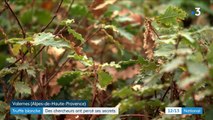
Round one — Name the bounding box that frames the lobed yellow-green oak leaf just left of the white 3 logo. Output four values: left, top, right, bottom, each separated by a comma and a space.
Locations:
156, 6, 187, 27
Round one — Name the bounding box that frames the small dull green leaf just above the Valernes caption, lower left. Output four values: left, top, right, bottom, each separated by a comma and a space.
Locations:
14, 82, 31, 94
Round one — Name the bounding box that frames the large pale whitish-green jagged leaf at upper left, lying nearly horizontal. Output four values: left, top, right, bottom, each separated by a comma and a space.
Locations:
32, 33, 70, 48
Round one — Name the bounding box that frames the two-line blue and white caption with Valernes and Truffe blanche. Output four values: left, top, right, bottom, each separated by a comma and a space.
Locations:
10, 100, 119, 115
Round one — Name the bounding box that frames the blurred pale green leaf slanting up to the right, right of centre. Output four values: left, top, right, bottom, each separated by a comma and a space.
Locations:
161, 57, 184, 72
